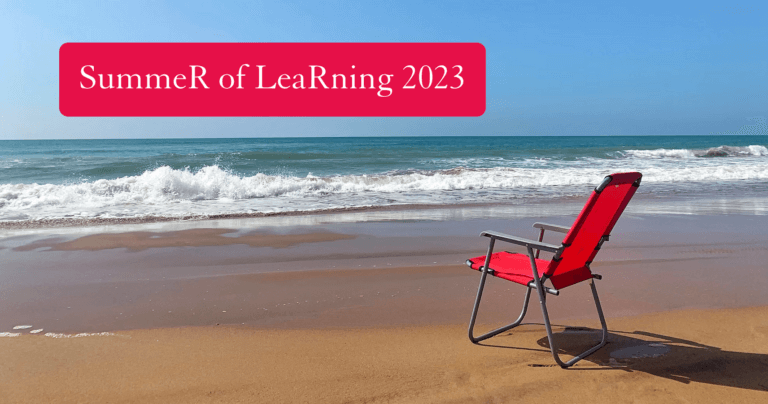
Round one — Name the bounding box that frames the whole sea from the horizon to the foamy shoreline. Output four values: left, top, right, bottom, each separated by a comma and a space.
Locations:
0, 135, 768, 223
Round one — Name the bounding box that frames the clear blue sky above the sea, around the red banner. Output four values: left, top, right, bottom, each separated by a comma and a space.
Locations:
0, 0, 768, 139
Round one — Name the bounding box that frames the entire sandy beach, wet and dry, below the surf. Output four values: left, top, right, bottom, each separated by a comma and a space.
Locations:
0, 213, 768, 403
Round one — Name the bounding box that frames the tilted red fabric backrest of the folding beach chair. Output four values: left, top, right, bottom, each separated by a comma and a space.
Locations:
545, 172, 642, 289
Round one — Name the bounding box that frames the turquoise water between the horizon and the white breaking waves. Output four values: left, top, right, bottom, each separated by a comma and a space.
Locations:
0, 136, 768, 184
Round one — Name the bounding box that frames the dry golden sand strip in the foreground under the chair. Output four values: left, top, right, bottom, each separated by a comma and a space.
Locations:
0, 307, 768, 403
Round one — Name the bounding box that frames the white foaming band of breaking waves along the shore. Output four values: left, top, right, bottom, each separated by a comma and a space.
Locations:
0, 145, 768, 221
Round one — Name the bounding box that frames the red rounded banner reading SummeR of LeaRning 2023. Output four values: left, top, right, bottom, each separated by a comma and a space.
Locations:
59, 43, 486, 117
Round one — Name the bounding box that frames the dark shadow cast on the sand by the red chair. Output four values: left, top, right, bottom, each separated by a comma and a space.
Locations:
480, 323, 768, 392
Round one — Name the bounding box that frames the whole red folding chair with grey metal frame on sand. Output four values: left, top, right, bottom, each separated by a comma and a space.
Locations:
467, 172, 642, 368
